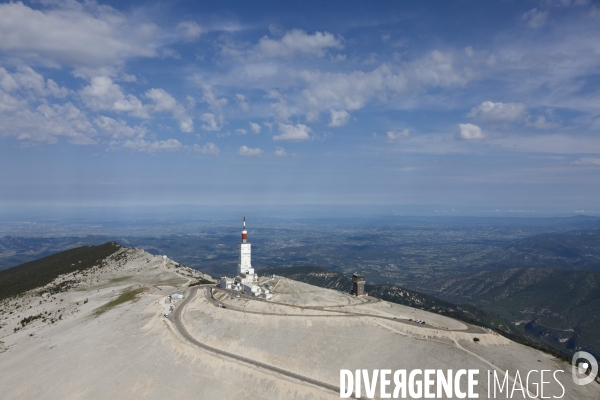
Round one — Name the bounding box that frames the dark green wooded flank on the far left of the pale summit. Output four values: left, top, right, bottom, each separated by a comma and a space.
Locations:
0, 242, 122, 300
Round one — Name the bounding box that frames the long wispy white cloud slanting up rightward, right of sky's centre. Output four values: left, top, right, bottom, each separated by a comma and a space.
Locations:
258, 50, 478, 122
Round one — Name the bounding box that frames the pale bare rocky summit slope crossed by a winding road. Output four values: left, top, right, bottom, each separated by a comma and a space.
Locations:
0, 248, 600, 399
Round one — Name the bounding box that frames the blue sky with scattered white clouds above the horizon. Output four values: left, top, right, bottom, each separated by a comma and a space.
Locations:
0, 0, 600, 213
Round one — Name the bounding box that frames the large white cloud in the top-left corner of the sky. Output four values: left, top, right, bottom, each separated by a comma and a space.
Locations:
0, 1, 158, 69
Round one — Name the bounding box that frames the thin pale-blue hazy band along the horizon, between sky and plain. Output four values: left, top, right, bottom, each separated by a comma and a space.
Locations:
0, 203, 600, 221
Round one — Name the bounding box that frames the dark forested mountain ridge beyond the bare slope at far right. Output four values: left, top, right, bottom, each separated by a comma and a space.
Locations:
427, 268, 600, 360
